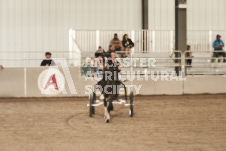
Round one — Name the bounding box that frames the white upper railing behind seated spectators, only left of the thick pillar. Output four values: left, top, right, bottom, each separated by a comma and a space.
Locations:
72, 30, 175, 52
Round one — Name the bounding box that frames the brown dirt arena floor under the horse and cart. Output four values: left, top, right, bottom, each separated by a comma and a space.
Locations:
0, 95, 226, 151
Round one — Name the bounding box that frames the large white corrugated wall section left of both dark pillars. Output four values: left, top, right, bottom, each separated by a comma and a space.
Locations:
0, 0, 142, 55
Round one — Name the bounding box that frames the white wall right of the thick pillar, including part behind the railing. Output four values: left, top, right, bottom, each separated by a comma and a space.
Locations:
187, 0, 226, 51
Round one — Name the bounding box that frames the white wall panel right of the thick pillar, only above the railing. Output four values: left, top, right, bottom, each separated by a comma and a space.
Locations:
187, 0, 226, 30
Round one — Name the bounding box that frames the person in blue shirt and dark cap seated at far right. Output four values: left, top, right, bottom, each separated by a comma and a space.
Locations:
212, 35, 226, 62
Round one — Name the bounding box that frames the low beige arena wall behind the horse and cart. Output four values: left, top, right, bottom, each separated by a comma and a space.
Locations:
0, 67, 226, 97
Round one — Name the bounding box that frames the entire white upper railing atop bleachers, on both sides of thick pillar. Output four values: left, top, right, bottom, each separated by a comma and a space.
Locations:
73, 30, 226, 52
